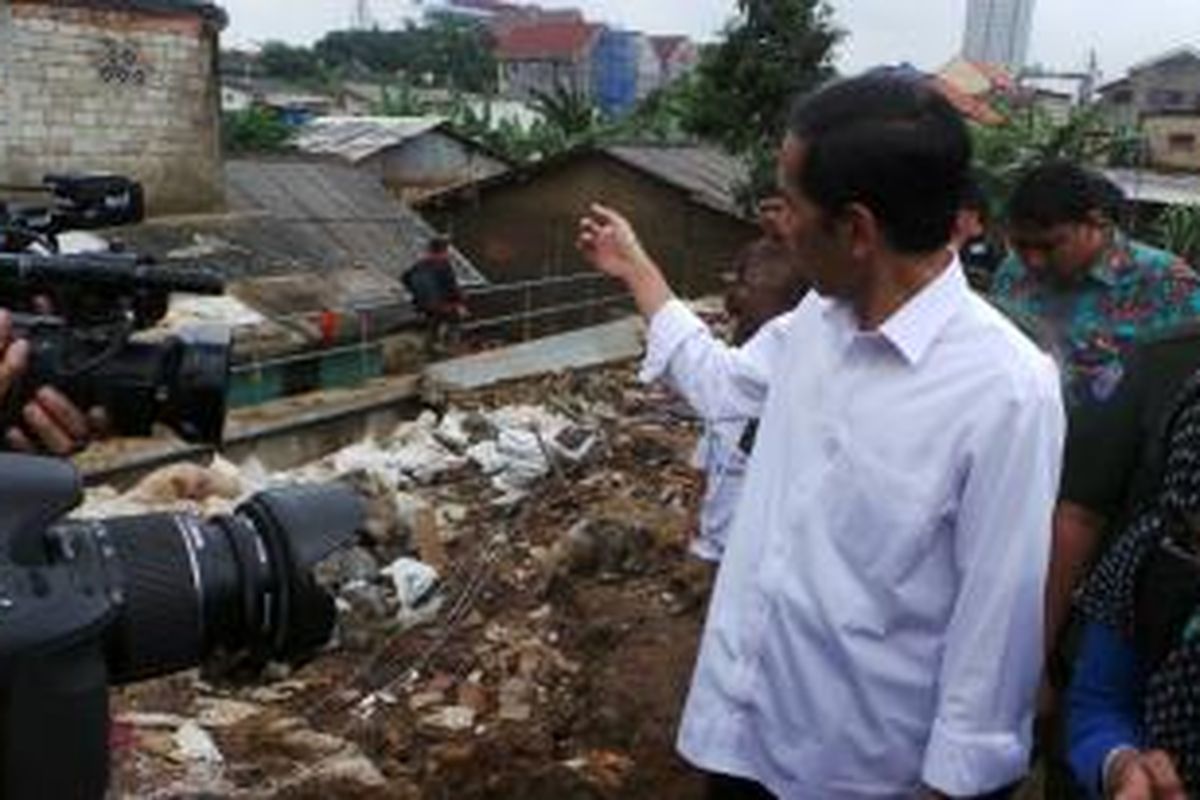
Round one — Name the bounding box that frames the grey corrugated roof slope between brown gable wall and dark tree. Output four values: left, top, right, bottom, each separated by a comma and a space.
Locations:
604, 145, 750, 216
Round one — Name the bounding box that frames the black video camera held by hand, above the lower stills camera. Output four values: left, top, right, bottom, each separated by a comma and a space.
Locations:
0, 175, 232, 444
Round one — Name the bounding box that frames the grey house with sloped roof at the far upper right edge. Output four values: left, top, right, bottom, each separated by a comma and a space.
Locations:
1097, 47, 1200, 127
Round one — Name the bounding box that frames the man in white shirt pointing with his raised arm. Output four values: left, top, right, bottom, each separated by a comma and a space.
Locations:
580, 72, 1063, 800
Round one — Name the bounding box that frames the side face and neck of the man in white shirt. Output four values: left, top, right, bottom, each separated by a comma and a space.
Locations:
779, 136, 865, 299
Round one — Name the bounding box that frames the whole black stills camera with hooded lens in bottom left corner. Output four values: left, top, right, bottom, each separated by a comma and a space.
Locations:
0, 455, 364, 800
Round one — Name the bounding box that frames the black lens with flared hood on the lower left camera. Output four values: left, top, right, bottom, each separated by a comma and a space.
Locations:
53, 485, 364, 684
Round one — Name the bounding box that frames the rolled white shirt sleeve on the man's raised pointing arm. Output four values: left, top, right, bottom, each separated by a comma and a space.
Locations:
641, 300, 798, 425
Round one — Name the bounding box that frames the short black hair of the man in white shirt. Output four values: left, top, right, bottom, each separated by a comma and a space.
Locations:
788, 68, 971, 253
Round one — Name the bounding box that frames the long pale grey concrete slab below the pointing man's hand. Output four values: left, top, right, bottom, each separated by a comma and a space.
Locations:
424, 317, 646, 397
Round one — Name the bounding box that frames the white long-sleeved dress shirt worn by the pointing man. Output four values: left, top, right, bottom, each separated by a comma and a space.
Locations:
642, 263, 1064, 800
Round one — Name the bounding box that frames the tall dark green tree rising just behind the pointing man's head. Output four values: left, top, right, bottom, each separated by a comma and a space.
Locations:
684, 0, 842, 169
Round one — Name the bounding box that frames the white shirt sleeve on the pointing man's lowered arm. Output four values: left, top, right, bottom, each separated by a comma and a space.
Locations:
922, 360, 1066, 796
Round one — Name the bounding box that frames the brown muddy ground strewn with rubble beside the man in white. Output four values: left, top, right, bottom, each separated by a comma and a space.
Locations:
112, 366, 710, 800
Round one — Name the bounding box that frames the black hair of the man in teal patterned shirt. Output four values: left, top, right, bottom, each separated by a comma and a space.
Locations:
1008, 161, 1126, 228
